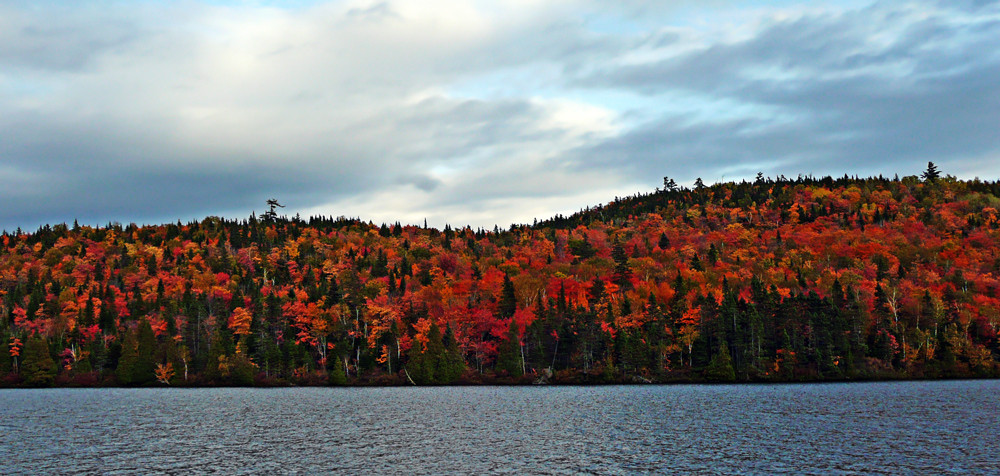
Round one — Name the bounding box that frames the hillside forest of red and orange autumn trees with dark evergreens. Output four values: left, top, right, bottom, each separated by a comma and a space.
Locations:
0, 164, 1000, 387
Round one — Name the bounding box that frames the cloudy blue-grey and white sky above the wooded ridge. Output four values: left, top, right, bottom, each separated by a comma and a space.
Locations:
0, 0, 1000, 230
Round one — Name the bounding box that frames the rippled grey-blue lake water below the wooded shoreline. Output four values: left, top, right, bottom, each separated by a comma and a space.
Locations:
0, 380, 1000, 474
